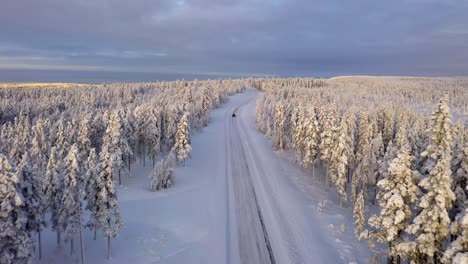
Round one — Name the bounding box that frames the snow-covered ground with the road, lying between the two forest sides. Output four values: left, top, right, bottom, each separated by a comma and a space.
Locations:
39, 89, 370, 264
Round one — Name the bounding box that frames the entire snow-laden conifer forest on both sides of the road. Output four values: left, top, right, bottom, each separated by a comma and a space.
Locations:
0, 77, 468, 263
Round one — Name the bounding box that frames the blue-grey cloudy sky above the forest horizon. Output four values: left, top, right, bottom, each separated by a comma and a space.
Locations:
0, 0, 468, 80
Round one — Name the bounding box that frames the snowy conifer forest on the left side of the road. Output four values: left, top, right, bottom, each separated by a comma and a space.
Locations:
0, 80, 248, 263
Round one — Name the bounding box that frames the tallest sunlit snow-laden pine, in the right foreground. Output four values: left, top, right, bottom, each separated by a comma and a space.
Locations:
398, 96, 455, 262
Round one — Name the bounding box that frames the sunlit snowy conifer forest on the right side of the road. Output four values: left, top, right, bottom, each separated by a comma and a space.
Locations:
253, 77, 468, 264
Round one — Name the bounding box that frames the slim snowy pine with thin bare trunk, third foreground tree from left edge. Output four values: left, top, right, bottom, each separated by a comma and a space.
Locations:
44, 147, 63, 246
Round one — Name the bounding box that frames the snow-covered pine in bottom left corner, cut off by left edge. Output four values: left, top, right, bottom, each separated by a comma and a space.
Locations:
0, 154, 34, 264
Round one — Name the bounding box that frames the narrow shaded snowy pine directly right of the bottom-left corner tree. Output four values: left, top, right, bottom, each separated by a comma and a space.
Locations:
16, 153, 46, 258
